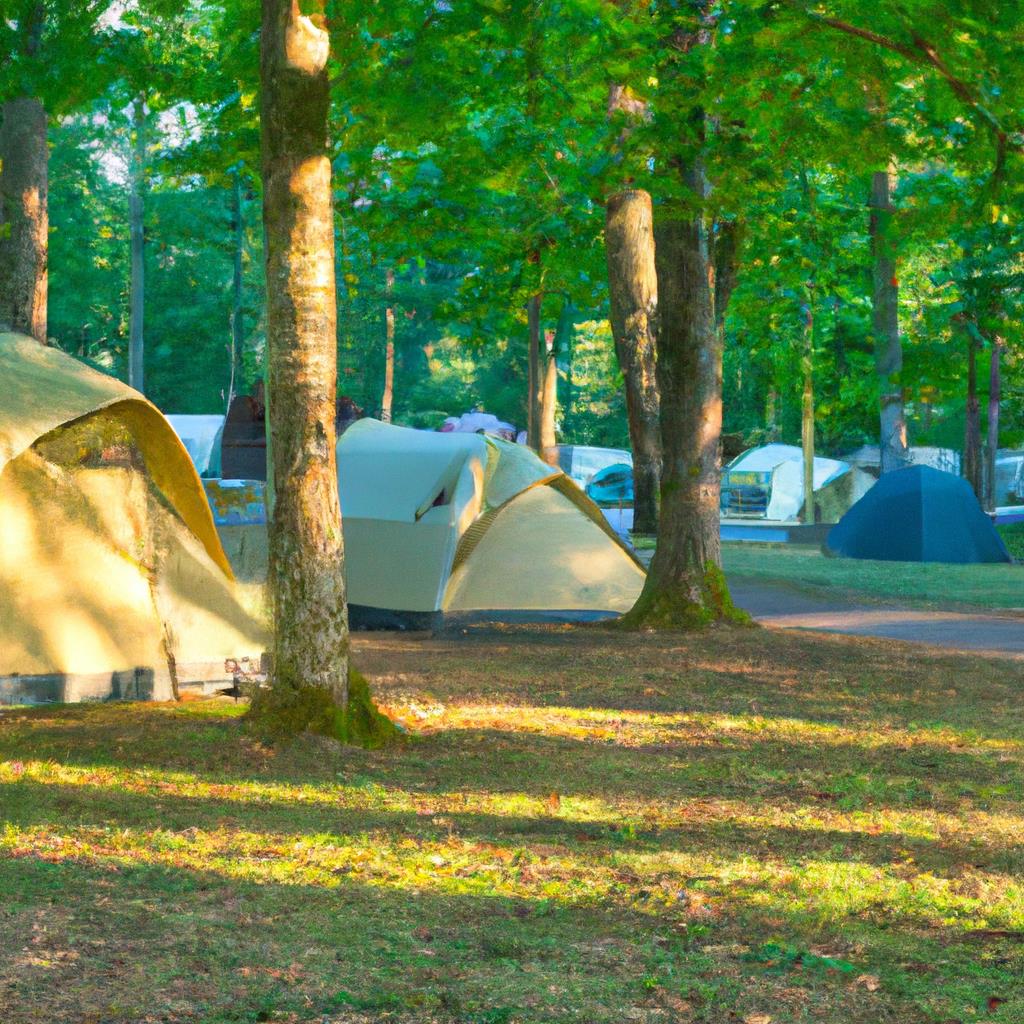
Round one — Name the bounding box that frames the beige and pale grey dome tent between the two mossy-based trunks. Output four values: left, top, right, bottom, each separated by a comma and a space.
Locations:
338, 419, 644, 621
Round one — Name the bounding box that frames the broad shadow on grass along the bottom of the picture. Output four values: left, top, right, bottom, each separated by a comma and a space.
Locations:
0, 827, 1017, 1024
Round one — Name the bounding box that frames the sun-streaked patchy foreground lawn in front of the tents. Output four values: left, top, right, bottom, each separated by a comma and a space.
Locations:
0, 628, 1024, 1024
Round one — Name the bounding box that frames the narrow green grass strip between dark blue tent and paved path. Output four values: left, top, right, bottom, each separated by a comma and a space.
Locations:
722, 543, 1024, 609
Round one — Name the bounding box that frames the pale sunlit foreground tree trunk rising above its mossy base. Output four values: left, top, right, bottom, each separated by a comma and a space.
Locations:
260, 0, 349, 709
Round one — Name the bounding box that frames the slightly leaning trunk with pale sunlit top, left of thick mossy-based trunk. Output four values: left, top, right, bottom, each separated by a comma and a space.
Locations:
604, 189, 662, 534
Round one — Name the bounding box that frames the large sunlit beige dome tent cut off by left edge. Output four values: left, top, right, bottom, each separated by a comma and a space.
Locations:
0, 334, 264, 703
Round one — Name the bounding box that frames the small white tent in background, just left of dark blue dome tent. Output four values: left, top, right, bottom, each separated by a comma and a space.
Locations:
722, 444, 850, 522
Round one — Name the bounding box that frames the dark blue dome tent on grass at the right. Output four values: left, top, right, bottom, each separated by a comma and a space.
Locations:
826, 466, 1011, 563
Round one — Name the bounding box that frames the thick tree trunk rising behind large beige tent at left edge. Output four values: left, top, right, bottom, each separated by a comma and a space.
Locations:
0, 96, 49, 345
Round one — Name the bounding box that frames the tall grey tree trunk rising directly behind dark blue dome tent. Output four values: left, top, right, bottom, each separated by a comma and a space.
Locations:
869, 171, 908, 473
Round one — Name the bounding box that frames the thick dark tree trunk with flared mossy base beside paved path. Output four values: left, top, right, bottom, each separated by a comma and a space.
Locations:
622, 165, 746, 629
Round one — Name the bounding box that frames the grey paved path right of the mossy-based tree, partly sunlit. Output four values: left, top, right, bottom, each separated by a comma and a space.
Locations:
729, 578, 1024, 659
